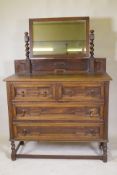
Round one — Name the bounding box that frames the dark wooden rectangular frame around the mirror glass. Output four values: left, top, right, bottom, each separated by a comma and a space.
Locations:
29, 17, 90, 58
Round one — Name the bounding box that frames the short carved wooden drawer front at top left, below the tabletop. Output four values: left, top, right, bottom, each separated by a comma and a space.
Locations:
12, 82, 54, 101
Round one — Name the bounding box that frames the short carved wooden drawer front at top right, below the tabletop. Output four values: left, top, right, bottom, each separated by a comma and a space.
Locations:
60, 82, 104, 101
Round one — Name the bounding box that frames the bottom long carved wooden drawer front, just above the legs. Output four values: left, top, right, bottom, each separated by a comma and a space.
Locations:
13, 123, 103, 141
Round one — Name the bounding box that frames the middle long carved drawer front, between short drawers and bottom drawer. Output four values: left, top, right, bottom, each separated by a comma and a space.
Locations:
13, 103, 103, 121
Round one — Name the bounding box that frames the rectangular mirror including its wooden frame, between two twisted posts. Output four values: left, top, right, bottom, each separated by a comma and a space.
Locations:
30, 18, 89, 57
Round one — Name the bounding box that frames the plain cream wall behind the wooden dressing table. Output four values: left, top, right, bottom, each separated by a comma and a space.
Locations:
0, 0, 117, 175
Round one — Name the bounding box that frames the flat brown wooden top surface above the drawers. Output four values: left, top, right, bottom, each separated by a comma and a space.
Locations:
4, 73, 111, 82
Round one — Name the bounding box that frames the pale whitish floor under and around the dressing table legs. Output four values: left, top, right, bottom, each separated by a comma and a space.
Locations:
0, 137, 117, 175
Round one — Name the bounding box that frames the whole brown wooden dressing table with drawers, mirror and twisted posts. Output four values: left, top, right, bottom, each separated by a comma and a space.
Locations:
5, 17, 111, 162
